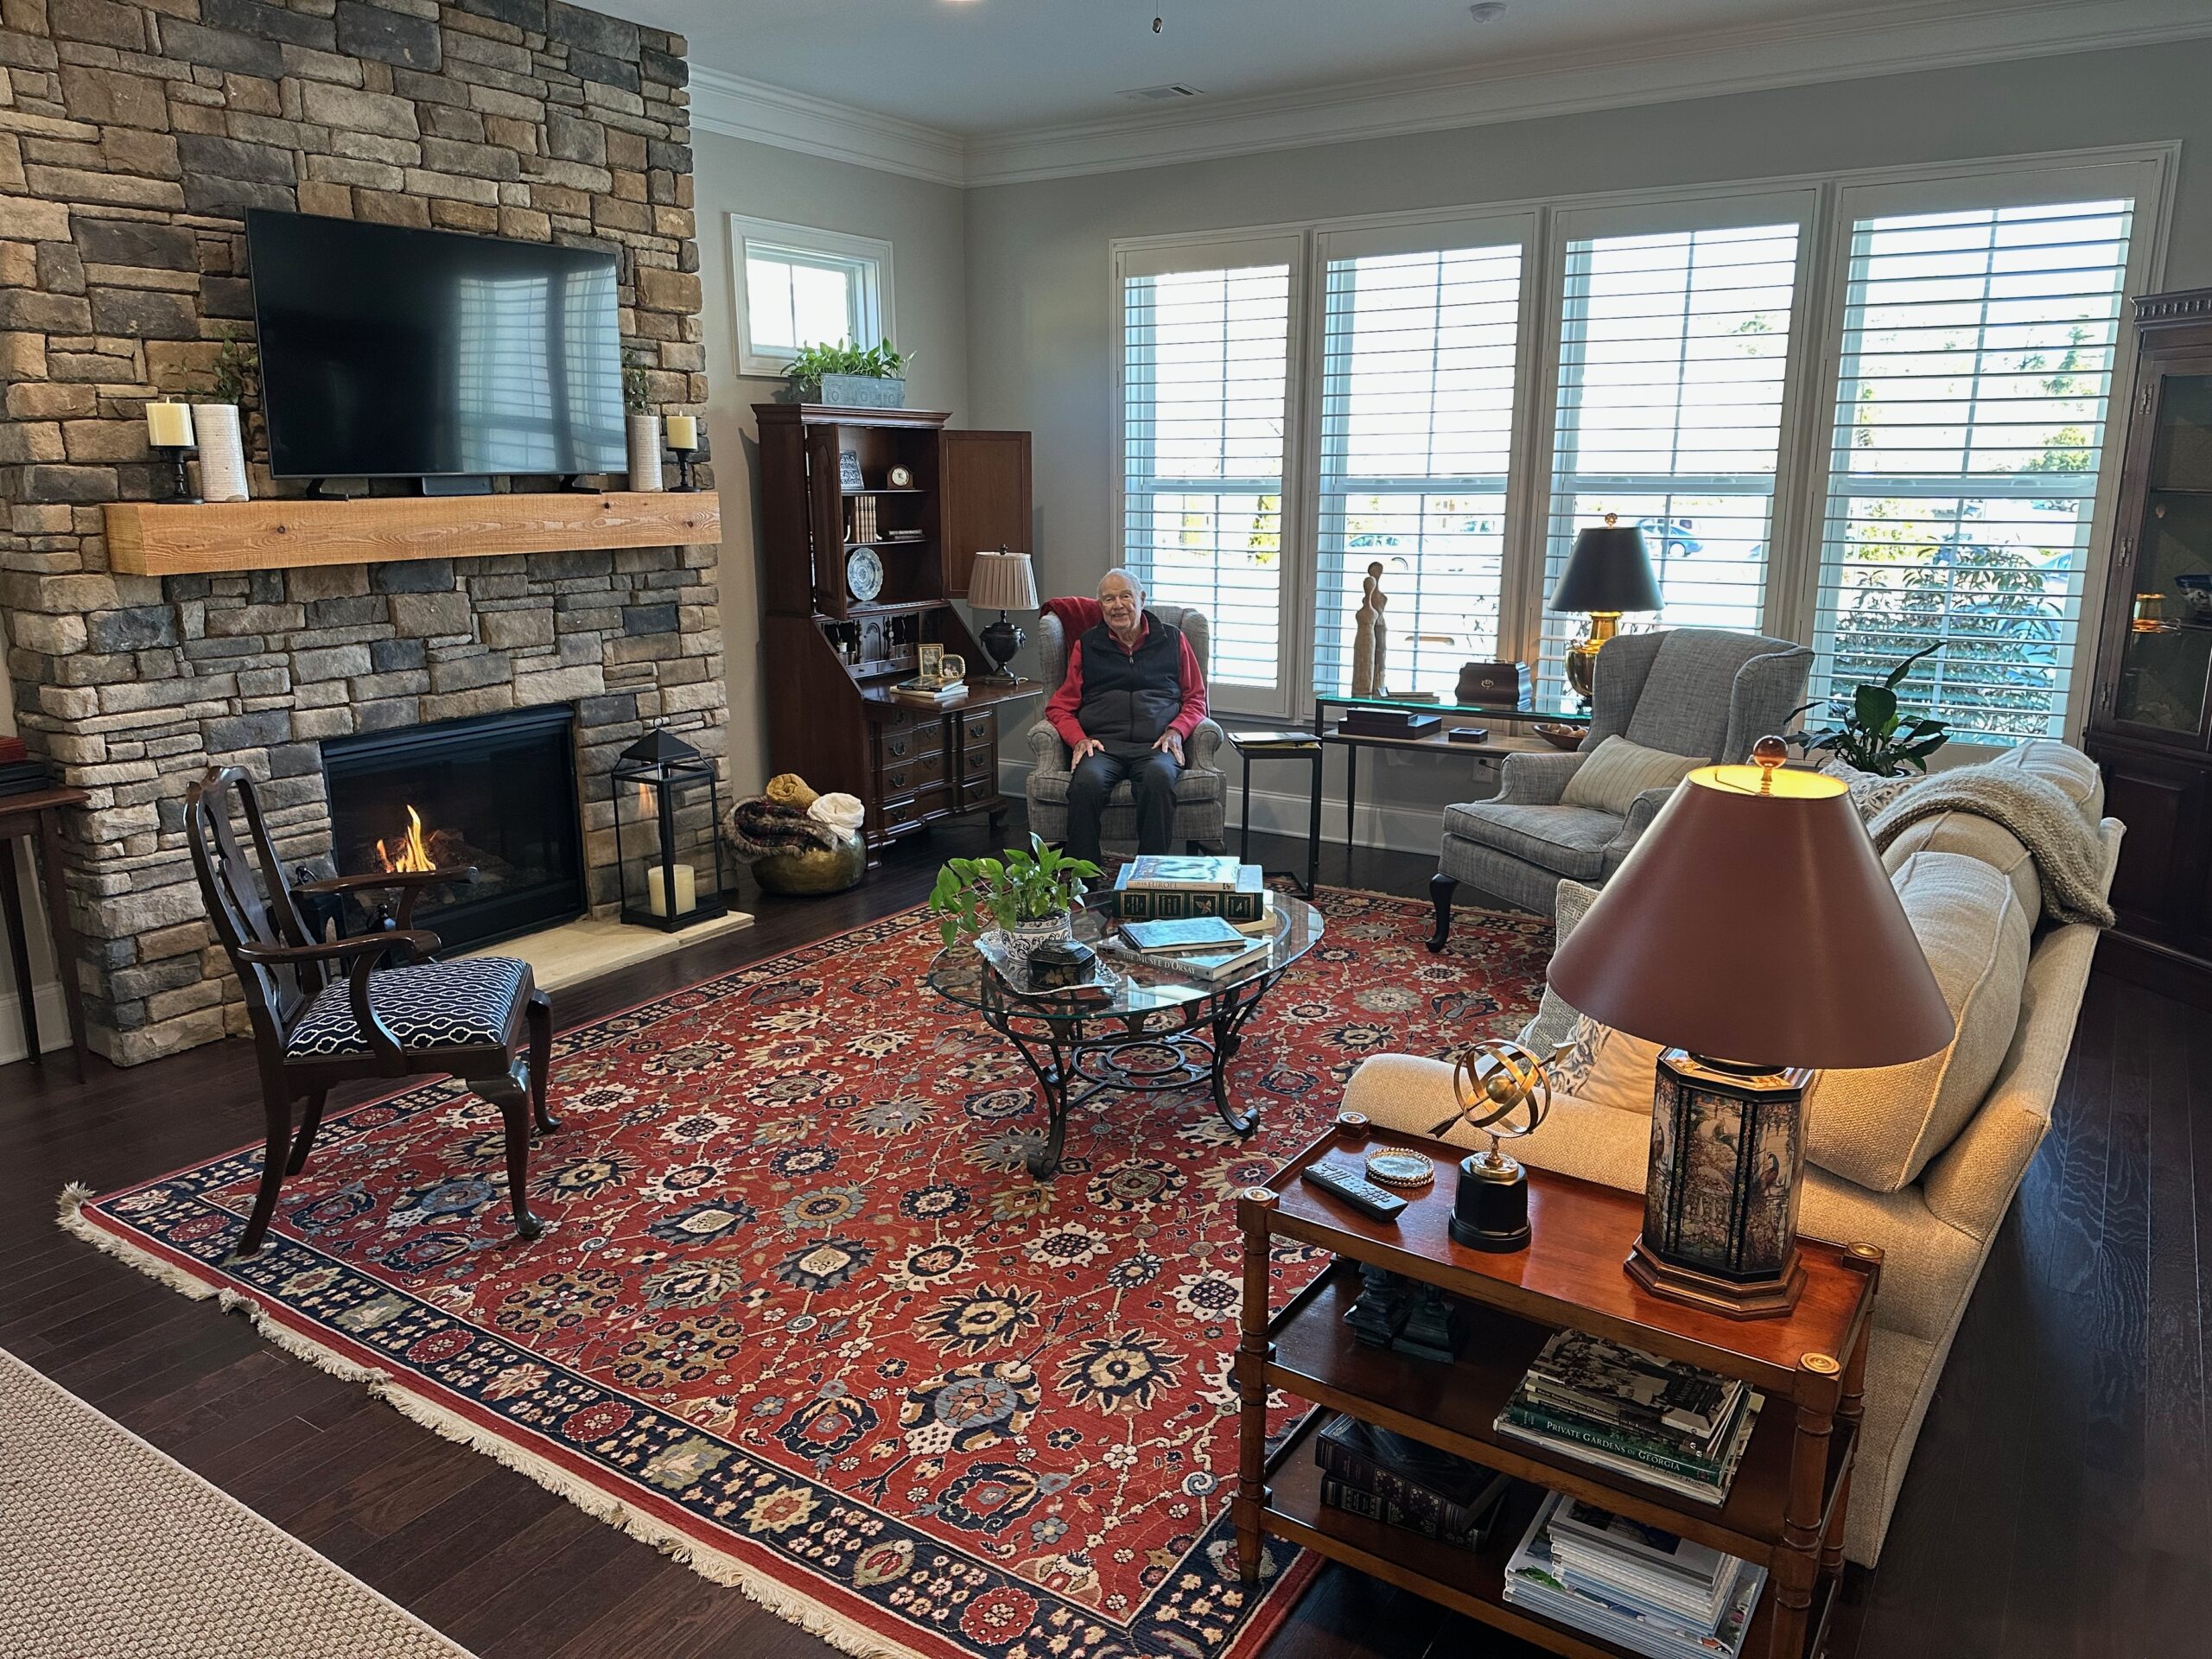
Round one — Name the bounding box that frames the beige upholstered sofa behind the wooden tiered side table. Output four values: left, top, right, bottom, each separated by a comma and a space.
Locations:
1344, 743, 2121, 1566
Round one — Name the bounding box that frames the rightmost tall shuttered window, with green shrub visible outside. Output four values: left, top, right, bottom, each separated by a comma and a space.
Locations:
1814, 199, 2133, 741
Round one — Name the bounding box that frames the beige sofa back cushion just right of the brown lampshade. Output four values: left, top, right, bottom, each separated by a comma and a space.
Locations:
1805, 852, 2029, 1192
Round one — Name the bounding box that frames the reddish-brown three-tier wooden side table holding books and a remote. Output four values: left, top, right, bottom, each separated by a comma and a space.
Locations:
1234, 1123, 1883, 1659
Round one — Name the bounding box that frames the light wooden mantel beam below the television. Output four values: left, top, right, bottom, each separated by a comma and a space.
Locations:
104, 489, 721, 575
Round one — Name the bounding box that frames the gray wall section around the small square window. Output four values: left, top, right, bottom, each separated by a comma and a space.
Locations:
695, 133, 973, 794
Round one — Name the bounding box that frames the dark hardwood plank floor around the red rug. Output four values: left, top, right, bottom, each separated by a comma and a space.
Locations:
0, 827, 2212, 1659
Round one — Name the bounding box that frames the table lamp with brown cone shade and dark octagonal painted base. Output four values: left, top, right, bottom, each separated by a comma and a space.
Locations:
1548, 736, 1953, 1319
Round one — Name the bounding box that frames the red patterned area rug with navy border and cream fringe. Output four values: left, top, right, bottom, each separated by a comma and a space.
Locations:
64, 889, 1551, 1659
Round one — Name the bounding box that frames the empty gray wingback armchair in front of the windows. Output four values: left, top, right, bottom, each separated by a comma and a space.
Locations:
1429, 628, 1812, 951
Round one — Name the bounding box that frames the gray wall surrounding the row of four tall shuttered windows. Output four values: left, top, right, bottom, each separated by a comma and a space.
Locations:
967, 40, 2212, 845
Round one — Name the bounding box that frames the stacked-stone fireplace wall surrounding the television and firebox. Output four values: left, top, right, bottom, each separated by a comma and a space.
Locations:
0, 0, 726, 1064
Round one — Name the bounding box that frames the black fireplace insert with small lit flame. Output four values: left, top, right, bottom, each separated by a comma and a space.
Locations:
323, 703, 588, 956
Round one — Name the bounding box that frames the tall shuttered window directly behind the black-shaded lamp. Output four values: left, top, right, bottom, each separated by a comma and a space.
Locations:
1541, 224, 1798, 690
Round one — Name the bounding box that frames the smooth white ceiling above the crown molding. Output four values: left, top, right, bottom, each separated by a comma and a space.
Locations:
595, 0, 2194, 135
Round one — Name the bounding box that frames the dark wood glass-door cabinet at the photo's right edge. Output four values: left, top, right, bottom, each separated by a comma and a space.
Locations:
2086, 289, 2212, 1007
